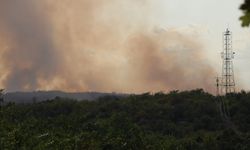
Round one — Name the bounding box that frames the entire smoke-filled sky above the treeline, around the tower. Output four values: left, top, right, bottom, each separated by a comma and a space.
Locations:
0, 0, 250, 93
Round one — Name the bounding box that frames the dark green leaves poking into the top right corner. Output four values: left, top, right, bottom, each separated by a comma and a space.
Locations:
240, 0, 250, 27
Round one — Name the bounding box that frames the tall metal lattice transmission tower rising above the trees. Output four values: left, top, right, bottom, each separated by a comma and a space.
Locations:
220, 29, 235, 94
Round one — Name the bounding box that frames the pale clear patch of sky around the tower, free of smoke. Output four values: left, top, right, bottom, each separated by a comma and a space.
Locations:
150, 0, 250, 90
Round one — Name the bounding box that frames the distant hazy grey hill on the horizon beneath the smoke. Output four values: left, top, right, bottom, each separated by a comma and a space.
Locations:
4, 91, 126, 103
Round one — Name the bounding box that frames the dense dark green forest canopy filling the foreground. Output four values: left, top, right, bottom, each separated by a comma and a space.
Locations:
0, 90, 250, 150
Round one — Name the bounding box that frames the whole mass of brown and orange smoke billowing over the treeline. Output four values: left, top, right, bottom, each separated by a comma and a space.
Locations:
0, 0, 214, 92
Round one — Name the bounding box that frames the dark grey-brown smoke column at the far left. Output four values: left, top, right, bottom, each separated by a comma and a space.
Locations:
0, 0, 57, 90
